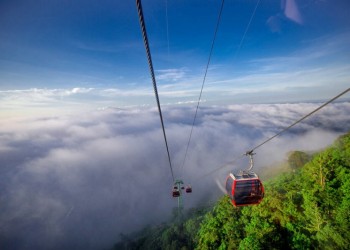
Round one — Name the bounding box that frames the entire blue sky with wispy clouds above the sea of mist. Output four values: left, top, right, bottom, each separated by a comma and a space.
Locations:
0, 0, 350, 116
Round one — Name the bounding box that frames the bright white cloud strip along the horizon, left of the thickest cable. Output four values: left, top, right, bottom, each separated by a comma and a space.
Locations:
0, 86, 154, 118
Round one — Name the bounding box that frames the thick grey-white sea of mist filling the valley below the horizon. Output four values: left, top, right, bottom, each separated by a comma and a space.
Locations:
0, 102, 350, 249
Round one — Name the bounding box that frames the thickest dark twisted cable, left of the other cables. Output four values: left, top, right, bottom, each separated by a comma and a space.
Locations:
136, 0, 175, 181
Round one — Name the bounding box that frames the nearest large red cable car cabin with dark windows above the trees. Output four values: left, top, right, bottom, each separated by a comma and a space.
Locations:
226, 172, 264, 207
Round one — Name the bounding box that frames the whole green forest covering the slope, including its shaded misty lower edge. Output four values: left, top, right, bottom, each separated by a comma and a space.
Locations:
112, 133, 350, 250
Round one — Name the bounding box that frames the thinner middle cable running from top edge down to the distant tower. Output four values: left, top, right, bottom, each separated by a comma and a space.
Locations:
182, 0, 225, 175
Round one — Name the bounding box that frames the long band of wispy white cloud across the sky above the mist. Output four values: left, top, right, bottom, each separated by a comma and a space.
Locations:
0, 33, 350, 117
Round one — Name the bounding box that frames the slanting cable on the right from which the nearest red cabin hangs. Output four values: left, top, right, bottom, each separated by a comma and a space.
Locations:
198, 88, 350, 179
